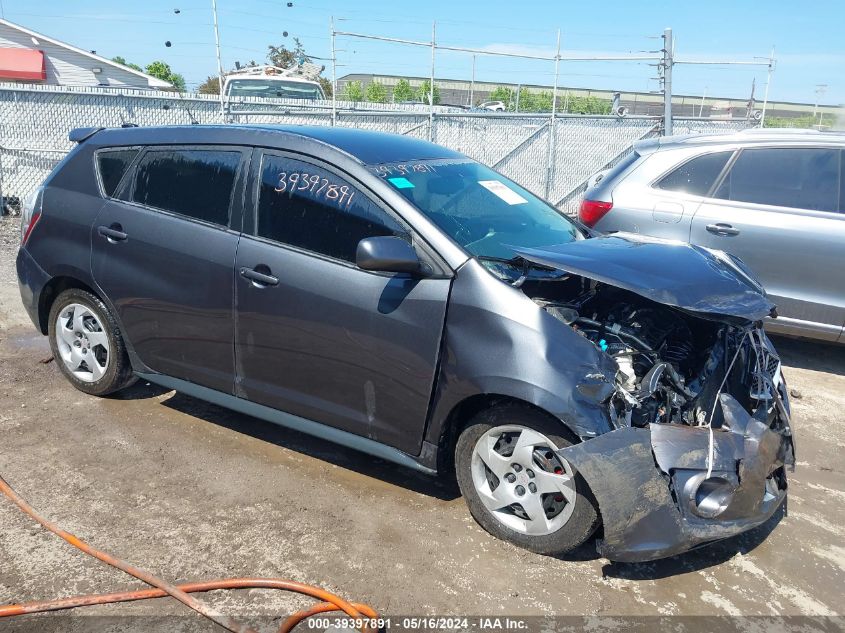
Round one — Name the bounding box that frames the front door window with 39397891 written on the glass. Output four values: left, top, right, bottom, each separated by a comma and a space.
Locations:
257, 156, 410, 262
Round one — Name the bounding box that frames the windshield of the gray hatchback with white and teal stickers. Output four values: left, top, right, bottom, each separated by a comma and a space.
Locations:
370, 159, 581, 260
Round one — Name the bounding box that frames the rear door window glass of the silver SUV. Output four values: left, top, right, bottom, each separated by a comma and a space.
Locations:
715, 148, 841, 211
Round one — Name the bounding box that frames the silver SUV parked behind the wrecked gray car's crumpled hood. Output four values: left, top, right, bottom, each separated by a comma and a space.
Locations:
579, 130, 845, 342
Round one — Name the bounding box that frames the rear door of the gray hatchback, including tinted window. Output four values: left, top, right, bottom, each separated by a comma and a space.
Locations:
91, 146, 249, 393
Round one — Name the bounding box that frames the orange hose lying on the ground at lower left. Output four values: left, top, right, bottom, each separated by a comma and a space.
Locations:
0, 476, 378, 633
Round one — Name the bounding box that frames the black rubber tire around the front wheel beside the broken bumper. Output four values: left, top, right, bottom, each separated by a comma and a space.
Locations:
455, 404, 600, 555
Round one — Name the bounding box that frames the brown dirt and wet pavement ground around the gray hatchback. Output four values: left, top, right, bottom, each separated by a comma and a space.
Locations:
0, 215, 845, 630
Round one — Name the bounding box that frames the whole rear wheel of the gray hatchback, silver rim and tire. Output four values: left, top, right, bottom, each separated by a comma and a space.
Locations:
48, 288, 135, 396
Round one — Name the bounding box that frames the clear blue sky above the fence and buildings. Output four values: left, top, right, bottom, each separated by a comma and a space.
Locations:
0, 0, 845, 104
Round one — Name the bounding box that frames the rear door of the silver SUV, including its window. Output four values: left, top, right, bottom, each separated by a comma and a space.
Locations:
690, 147, 845, 340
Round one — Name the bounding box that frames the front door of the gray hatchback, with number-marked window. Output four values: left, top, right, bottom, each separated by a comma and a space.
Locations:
235, 151, 451, 454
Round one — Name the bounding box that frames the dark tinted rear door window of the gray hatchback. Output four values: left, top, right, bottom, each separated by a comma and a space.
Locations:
132, 149, 241, 226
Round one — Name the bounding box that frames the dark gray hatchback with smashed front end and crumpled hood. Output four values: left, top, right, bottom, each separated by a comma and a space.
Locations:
17, 126, 794, 560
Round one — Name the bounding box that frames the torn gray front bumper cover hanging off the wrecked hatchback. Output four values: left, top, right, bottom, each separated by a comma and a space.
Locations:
559, 394, 794, 562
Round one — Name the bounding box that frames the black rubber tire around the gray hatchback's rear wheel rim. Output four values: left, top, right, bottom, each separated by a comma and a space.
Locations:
47, 288, 136, 396
